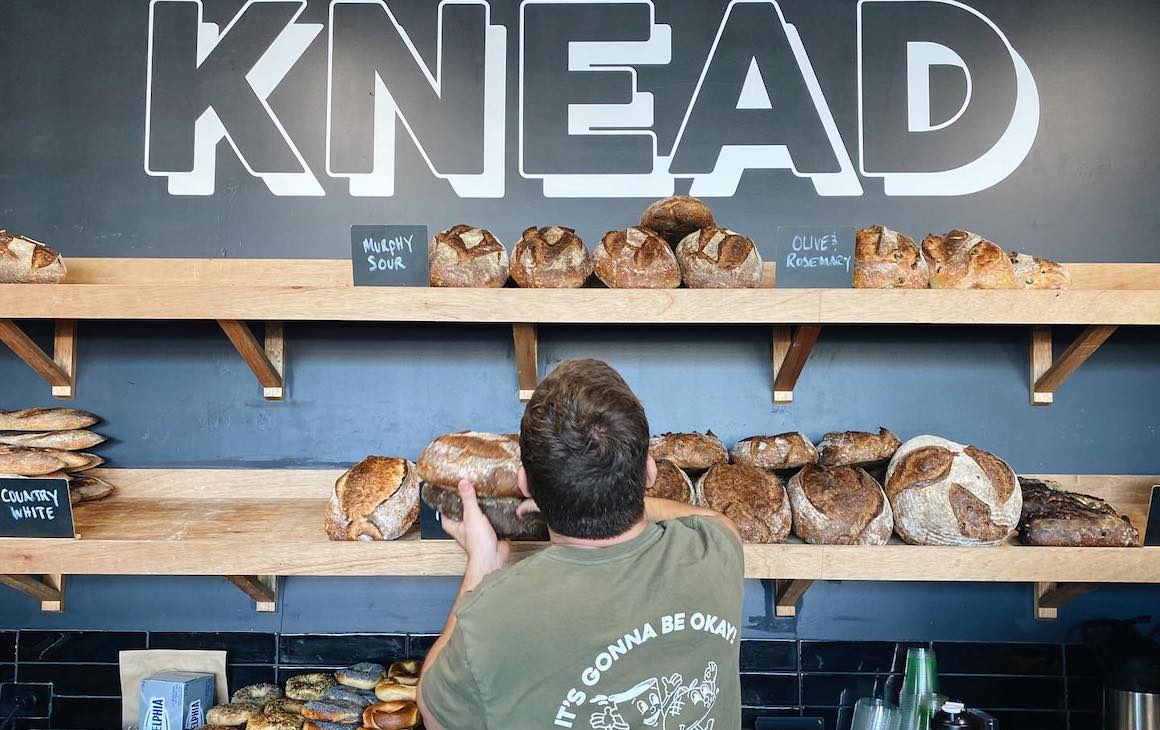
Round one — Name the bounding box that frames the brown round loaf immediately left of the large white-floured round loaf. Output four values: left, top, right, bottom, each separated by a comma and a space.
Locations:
785, 464, 894, 545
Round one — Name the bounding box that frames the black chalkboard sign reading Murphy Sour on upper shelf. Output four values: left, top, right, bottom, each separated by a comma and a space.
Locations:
350, 225, 428, 287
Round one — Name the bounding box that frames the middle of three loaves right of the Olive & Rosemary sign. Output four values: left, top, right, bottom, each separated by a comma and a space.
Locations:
922, 230, 1015, 289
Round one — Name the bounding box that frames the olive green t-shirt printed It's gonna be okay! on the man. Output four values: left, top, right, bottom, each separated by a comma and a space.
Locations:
422, 516, 744, 730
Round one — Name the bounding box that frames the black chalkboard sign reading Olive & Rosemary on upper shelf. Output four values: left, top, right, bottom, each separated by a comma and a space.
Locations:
761, 225, 855, 289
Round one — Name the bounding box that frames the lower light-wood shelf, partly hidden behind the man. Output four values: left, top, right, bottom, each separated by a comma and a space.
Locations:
0, 469, 1160, 584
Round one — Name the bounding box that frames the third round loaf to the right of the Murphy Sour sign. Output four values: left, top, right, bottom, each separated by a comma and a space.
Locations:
593, 229, 681, 289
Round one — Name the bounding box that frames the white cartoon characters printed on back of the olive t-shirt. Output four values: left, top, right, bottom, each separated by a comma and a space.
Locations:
588, 662, 719, 730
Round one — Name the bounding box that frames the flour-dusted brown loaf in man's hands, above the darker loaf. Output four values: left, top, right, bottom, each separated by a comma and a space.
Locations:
418, 431, 523, 498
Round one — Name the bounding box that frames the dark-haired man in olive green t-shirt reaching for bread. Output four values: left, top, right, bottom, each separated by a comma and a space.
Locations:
419, 360, 744, 730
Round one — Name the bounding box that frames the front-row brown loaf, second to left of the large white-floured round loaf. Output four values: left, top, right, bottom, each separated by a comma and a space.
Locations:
696, 464, 792, 543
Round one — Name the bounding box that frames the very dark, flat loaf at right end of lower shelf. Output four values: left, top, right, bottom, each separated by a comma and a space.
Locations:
1018, 477, 1140, 548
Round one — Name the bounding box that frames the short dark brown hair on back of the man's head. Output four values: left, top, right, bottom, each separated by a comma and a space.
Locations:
520, 360, 648, 540
